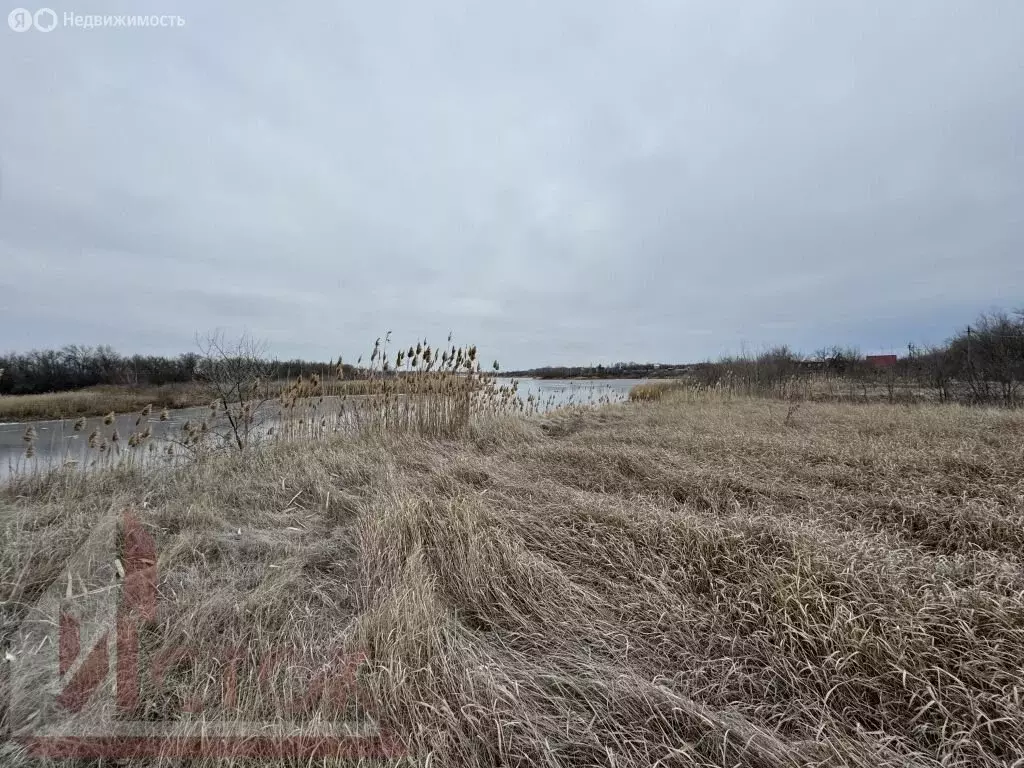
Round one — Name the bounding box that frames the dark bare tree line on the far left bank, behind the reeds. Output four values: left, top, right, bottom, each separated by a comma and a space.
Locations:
0, 346, 357, 394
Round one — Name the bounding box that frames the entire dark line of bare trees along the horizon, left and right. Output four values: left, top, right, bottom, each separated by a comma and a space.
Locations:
0, 310, 1024, 406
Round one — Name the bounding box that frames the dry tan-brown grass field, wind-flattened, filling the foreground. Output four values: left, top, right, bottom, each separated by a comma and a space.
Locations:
0, 392, 1024, 768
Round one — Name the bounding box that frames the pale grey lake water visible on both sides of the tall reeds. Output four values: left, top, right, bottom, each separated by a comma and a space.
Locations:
0, 378, 641, 478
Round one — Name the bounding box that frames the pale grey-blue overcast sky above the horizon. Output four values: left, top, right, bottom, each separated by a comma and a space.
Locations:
0, 0, 1024, 368
